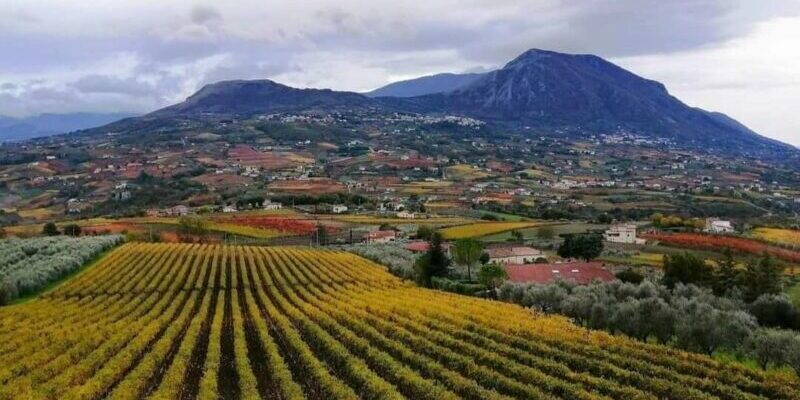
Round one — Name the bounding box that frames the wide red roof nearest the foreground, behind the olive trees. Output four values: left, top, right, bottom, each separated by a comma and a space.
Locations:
504, 262, 614, 285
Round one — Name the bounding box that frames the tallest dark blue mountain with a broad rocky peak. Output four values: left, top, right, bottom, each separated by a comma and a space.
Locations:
382, 49, 792, 155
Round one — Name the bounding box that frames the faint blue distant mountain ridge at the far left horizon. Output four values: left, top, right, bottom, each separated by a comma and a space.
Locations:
0, 113, 134, 142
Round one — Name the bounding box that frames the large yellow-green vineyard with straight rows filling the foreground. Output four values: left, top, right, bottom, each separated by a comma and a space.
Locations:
0, 243, 800, 400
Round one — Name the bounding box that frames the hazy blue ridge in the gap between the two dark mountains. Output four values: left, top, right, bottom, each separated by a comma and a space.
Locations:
364, 73, 486, 97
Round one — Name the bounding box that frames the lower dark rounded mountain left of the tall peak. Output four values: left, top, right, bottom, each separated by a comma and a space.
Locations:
148, 79, 373, 117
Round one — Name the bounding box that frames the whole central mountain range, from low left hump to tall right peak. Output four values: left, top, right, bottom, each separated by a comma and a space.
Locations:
89, 49, 797, 155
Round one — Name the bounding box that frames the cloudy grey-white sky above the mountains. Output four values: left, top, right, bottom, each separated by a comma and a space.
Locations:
0, 0, 800, 145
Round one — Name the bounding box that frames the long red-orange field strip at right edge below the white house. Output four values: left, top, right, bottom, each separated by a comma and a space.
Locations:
642, 233, 800, 263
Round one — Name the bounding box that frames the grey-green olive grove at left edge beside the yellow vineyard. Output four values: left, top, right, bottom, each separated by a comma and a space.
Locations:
0, 235, 122, 305
